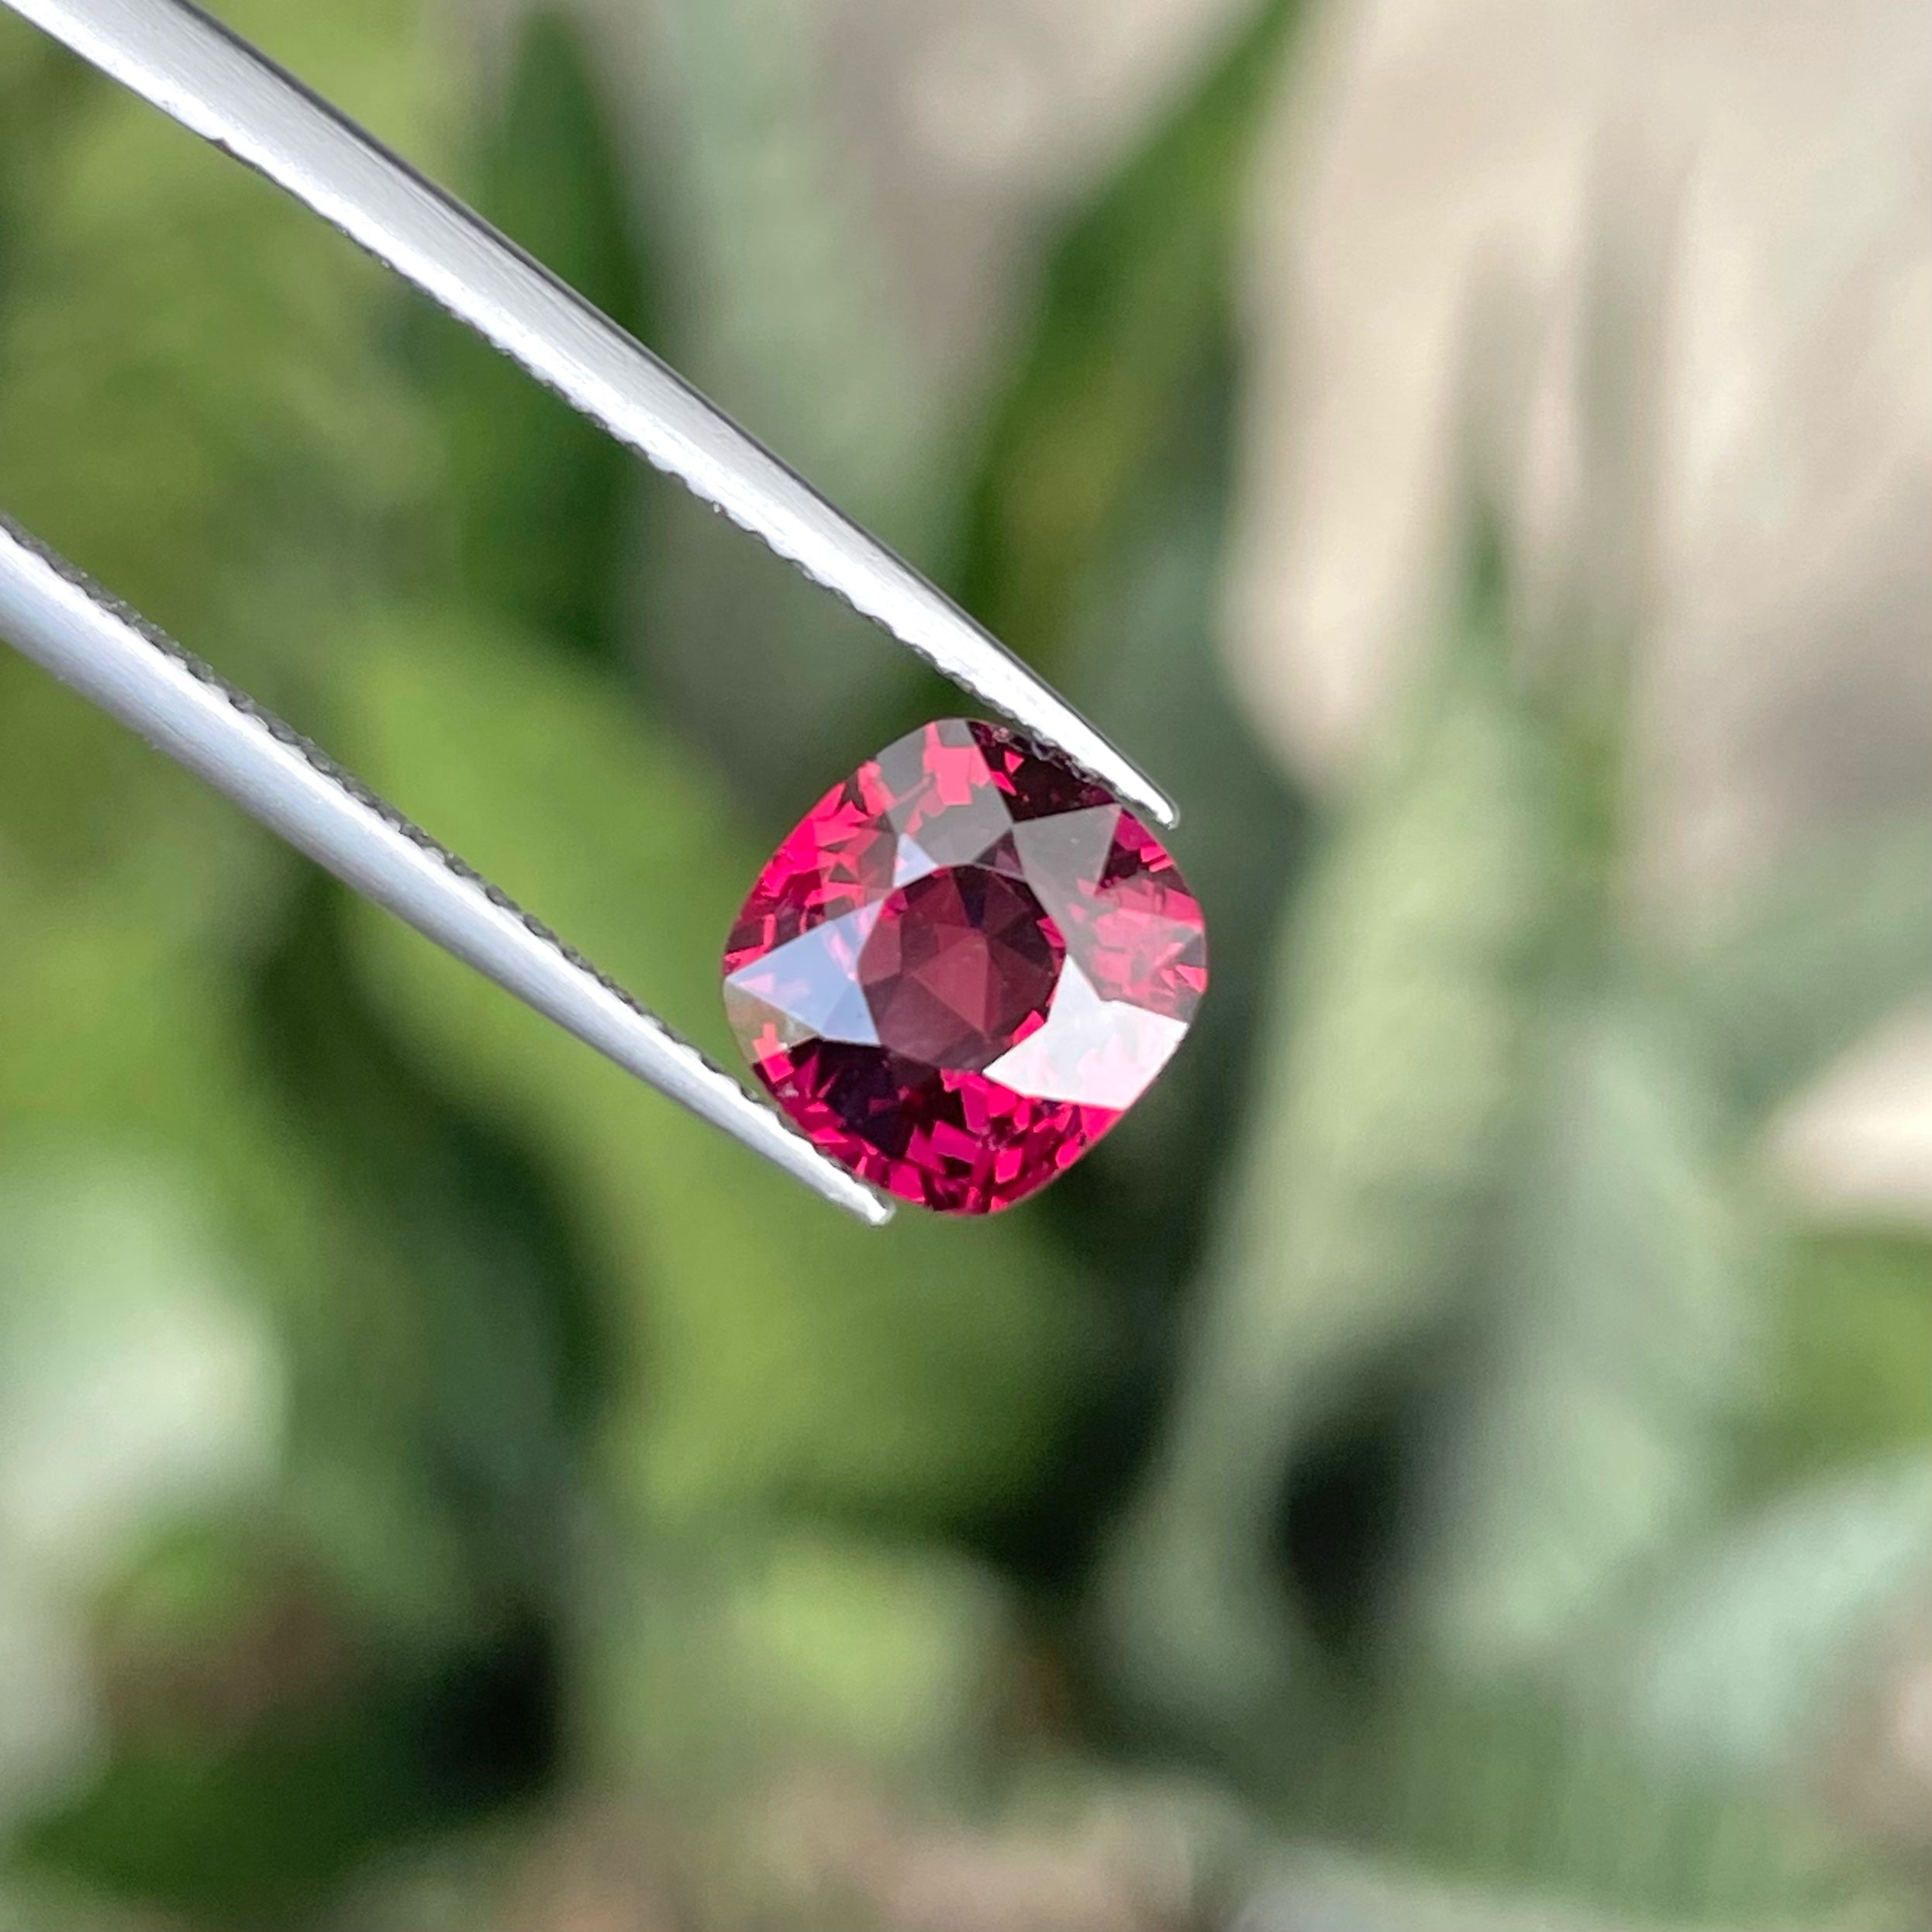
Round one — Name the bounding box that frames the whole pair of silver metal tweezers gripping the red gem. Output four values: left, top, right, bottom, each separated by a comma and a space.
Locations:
0, 0, 1175, 1225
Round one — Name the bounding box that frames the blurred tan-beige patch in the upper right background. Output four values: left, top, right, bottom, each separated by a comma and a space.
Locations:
1230, 0, 1932, 888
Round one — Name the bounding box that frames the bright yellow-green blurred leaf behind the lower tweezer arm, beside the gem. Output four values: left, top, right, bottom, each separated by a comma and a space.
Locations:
324, 620, 1089, 1519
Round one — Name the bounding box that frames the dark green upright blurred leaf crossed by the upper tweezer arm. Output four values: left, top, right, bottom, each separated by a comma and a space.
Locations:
421, 8, 653, 659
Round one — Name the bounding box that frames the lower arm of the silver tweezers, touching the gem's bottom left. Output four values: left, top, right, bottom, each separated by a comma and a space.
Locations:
0, 518, 892, 1225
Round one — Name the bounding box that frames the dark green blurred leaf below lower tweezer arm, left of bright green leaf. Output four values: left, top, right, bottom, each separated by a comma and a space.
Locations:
255, 875, 603, 1603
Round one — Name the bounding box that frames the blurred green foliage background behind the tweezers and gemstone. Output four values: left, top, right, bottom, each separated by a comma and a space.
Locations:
0, 0, 1932, 1932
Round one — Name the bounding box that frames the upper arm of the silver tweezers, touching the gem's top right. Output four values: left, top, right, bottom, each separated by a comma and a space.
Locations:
4, 0, 1175, 825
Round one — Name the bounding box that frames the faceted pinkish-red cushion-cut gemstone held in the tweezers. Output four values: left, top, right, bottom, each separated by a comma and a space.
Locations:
725, 719, 1208, 1213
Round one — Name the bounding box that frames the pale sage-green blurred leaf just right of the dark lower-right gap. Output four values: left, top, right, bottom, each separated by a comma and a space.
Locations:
1395, 991, 1766, 1675
